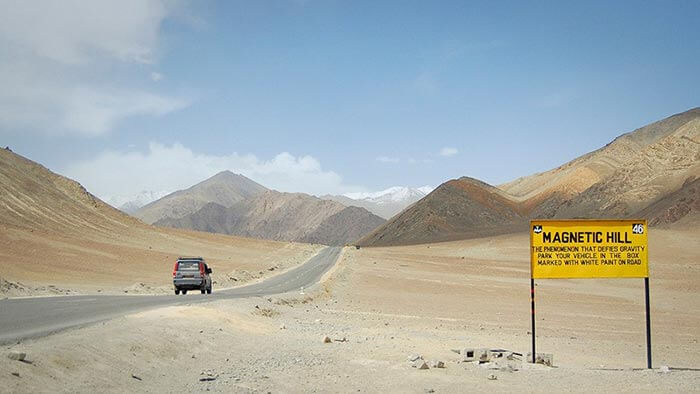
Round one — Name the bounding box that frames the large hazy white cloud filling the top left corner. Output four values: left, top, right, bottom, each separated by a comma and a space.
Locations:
0, 0, 188, 136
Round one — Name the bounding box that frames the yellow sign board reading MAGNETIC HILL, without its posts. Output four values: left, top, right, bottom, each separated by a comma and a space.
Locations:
530, 220, 649, 279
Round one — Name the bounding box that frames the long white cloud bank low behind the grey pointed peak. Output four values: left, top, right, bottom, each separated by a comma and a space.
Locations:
61, 143, 361, 200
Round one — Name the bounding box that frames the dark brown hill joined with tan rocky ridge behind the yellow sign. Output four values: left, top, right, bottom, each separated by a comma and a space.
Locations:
360, 108, 700, 246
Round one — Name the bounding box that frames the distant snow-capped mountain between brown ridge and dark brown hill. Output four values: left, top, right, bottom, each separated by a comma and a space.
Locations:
321, 186, 433, 219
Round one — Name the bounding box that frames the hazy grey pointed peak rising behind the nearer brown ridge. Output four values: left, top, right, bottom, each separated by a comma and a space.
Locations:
134, 171, 267, 224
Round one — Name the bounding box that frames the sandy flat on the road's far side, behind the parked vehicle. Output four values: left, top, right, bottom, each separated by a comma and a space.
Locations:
0, 226, 323, 296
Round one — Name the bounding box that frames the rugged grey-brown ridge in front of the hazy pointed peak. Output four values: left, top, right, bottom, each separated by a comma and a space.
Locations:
156, 190, 384, 245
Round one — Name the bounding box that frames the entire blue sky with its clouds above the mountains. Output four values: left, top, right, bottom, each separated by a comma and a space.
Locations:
0, 0, 700, 202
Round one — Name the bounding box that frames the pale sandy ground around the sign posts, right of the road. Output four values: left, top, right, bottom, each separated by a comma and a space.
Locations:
0, 229, 700, 392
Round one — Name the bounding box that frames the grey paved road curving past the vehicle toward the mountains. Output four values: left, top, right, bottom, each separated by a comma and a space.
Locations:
0, 247, 341, 344
